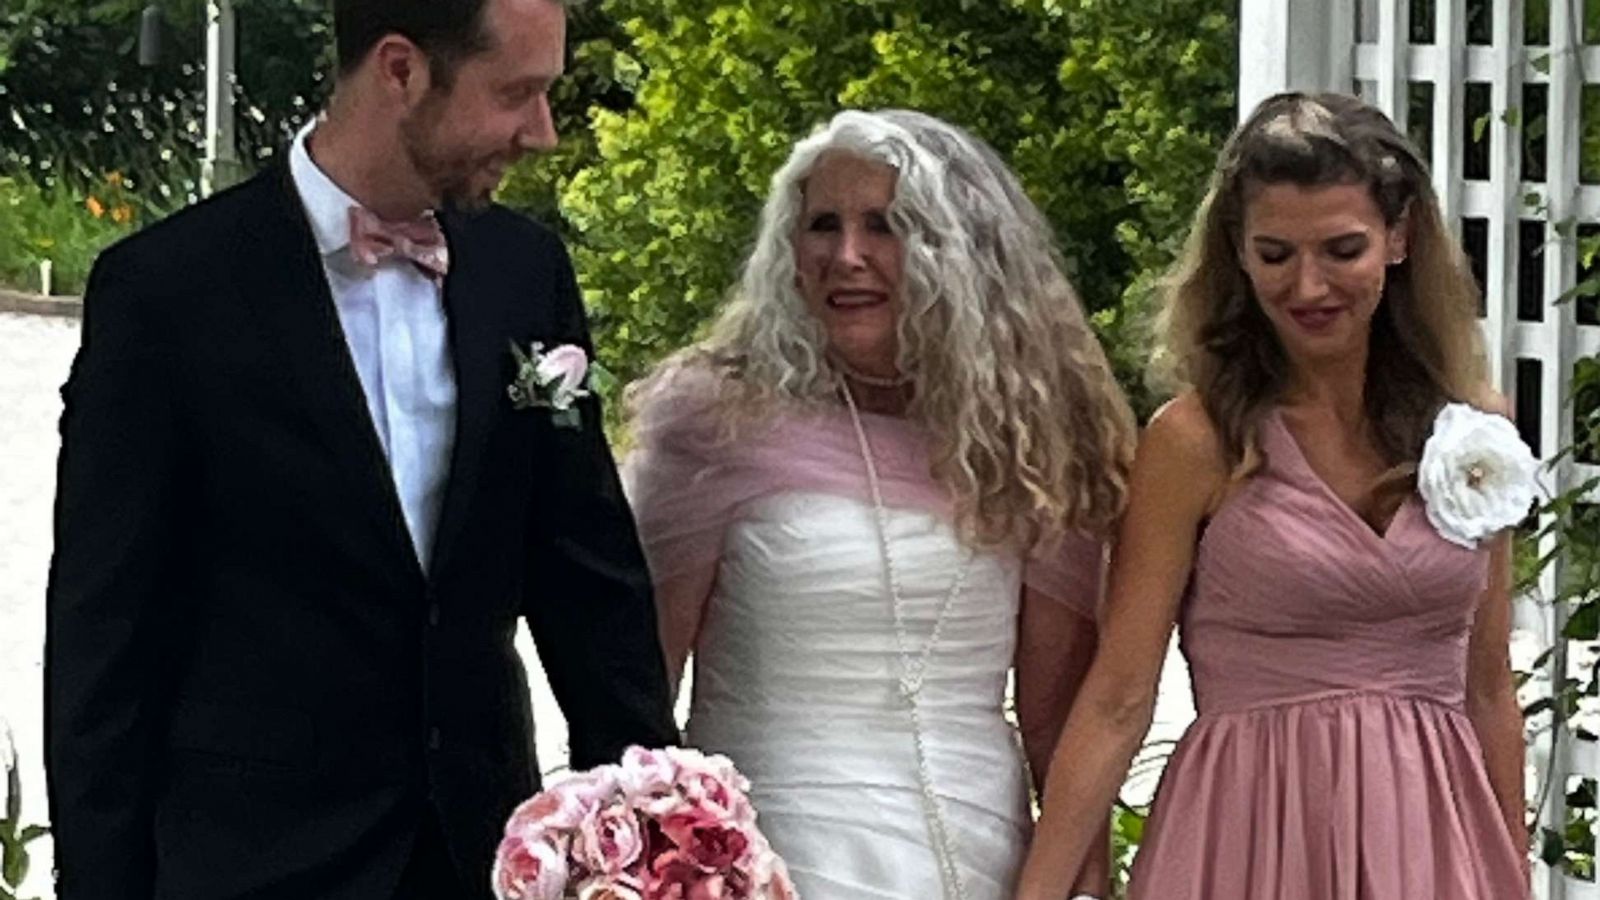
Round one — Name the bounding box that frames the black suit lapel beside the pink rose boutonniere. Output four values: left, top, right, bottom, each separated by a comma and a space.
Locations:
434, 216, 510, 572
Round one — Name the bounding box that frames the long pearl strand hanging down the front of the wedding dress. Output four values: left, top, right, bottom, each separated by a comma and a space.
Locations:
840, 383, 974, 900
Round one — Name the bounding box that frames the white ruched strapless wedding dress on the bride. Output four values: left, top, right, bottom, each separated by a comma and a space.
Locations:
688, 492, 1030, 900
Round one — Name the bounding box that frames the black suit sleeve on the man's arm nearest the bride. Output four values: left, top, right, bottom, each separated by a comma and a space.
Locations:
523, 237, 680, 769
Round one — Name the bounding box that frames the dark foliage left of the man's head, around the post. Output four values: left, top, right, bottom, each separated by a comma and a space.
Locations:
0, 0, 331, 205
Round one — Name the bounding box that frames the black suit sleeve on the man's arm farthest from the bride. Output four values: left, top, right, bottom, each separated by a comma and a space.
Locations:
45, 256, 178, 900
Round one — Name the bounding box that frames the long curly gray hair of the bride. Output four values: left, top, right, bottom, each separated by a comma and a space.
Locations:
634, 110, 1134, 546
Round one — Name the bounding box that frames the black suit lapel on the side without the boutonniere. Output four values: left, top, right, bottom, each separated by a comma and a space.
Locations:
238, 163, 422, 578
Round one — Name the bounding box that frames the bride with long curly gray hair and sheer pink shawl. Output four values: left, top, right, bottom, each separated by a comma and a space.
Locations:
629, 110, 1133, 900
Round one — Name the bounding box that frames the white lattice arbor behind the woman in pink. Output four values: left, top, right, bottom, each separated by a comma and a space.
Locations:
1238, 0, 1600, 900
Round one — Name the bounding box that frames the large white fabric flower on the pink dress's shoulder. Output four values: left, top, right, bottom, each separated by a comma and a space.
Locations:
1416, 404, 1539, 549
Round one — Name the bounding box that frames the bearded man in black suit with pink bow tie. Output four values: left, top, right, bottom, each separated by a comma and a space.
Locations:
46, 0, 677, 900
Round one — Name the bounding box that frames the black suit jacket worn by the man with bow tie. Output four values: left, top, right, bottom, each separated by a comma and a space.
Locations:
45, 165, 677, 900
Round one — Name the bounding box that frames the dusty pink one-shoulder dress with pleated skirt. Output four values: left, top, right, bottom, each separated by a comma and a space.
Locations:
1130, 410, 1528, 900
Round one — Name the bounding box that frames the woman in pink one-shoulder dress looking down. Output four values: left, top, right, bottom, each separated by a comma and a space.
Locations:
1016, 94, 1533, 900
